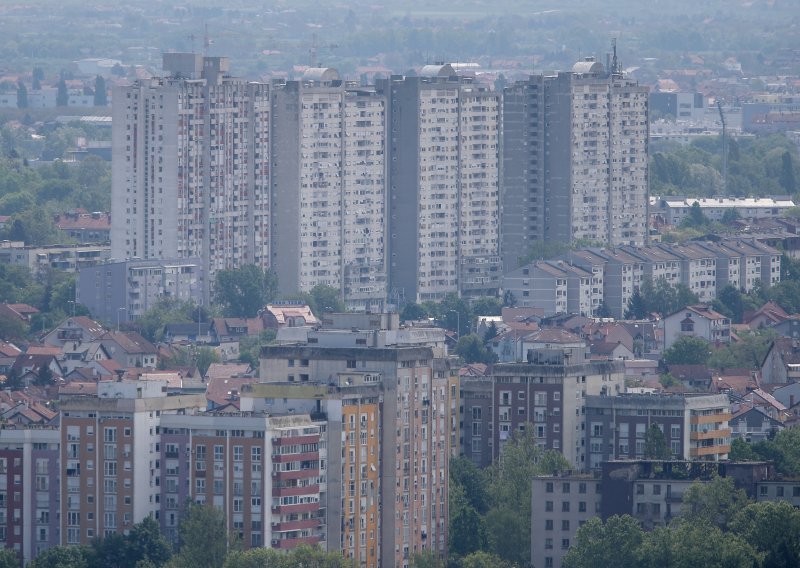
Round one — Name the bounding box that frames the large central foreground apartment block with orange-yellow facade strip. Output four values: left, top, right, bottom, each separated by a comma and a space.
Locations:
252, 314, 451, 567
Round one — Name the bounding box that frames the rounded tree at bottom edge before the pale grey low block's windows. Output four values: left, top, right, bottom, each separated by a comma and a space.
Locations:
561, 515, 644, 568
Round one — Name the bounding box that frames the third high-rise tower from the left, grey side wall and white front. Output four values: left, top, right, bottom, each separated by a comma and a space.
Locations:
377, 65, 500, 302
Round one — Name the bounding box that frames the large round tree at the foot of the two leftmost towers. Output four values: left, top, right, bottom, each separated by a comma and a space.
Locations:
214, 264, 278, 318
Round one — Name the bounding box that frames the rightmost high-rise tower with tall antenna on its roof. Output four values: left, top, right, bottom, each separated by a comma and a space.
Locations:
503, 58, 648, 270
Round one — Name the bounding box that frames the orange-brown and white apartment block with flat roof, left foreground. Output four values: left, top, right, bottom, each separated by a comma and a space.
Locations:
55, 381, 206, 545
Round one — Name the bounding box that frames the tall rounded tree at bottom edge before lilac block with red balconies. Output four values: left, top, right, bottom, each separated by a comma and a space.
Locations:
172, 503, 229, 568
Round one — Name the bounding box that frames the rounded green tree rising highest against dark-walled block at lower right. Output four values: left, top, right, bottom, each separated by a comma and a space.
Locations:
681, 476, 748, 530
